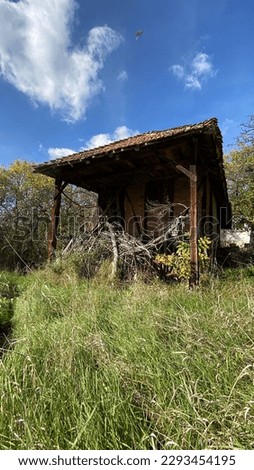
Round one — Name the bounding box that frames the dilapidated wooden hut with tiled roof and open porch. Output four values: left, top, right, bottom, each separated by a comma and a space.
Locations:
35, 118, 230, 284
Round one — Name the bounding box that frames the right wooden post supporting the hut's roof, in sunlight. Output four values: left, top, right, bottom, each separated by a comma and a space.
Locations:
189, 165, 199, 289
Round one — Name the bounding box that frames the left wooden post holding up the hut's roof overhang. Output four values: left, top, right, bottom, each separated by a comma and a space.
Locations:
48, 178, 63, 261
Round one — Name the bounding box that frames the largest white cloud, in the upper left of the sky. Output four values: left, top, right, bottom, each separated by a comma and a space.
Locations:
0, 0, 123, 122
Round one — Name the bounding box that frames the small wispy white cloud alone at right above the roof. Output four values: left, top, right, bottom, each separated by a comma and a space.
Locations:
170, 52, 217, 90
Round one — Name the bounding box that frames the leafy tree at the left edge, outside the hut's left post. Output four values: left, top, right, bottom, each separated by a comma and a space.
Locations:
0, 160, 53, 269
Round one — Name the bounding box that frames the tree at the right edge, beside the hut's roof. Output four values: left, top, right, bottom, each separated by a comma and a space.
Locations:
225, 115, 254, 246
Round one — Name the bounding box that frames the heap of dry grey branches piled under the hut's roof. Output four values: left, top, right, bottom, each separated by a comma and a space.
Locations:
63, 203, 189, 279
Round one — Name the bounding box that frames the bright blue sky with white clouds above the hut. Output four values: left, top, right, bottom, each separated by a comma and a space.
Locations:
0, 0, 254, 165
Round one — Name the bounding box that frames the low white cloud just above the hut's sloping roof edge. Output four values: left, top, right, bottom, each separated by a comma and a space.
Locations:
48, 126, 139, 159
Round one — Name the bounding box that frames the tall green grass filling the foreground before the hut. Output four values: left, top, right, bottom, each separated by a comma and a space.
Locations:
0, 268, 254, 449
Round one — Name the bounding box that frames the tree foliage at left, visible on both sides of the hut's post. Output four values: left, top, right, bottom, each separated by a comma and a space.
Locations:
0, 160, 94, 269
